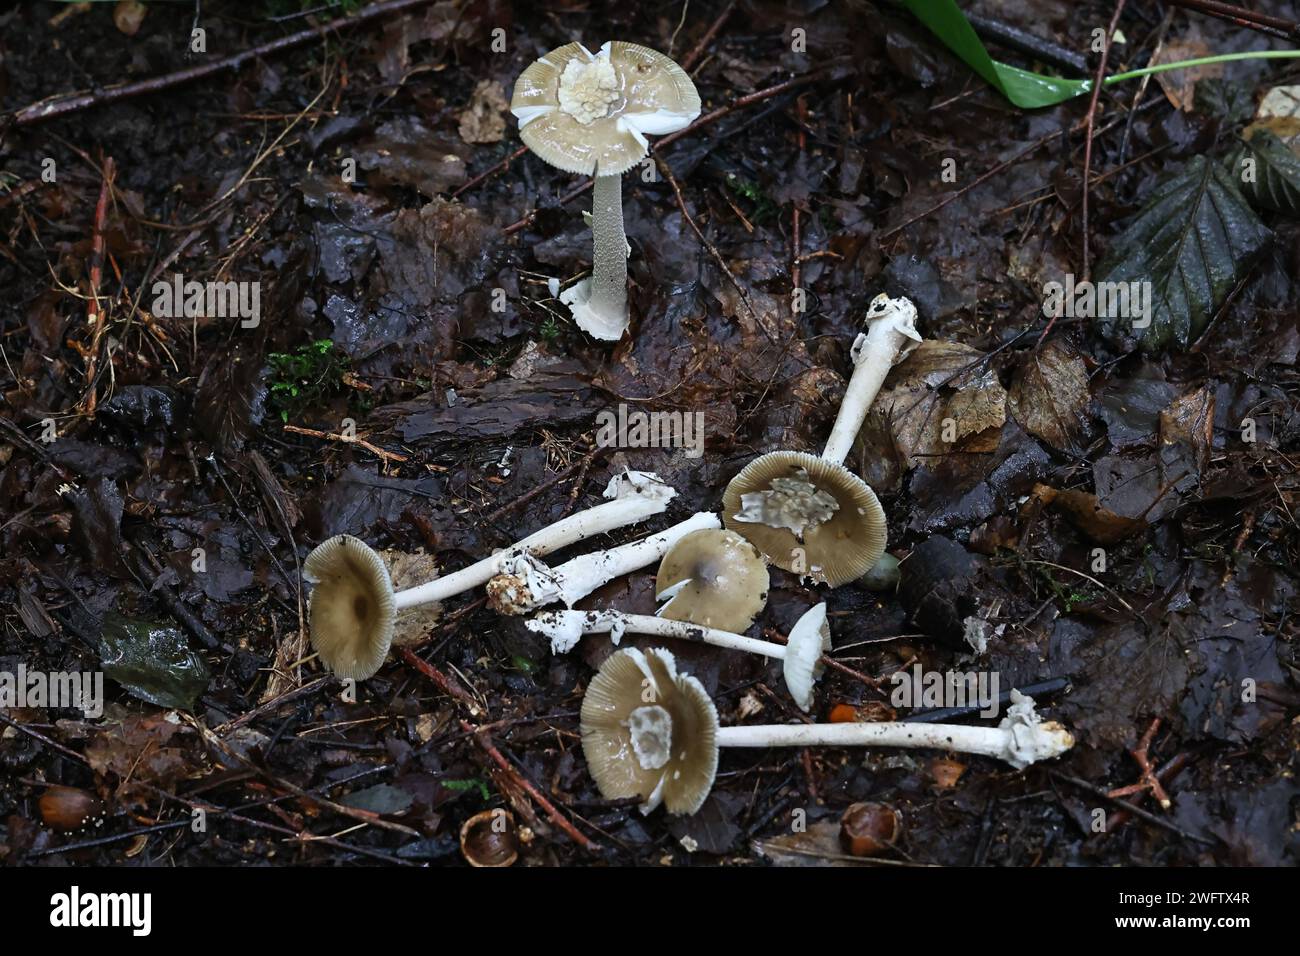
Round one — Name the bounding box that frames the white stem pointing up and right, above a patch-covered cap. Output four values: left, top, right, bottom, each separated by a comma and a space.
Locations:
822, 293, 920, 464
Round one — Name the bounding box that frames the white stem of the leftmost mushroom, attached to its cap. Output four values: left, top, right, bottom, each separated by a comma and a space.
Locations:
394, 471, 676, 611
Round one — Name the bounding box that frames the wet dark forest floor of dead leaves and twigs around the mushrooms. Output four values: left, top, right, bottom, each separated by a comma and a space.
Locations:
0, 0, 1300, 866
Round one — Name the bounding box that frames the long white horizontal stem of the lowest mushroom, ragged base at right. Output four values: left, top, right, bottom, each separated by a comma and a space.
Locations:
716, 691, 1074, 770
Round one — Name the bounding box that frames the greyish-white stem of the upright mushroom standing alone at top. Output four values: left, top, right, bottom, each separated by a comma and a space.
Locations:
560, 174, 628, 342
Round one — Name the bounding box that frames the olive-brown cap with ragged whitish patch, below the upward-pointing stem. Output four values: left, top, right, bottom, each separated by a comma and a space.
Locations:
723, 451, 888, 588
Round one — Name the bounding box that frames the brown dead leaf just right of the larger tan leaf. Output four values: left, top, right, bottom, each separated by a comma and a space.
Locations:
1010, 342, 1091, 451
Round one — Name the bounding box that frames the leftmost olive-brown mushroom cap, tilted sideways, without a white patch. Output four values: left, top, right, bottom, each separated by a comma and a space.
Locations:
303, 535, 397, 680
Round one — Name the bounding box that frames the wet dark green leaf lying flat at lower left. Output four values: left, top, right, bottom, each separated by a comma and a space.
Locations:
100, 614, 208, 710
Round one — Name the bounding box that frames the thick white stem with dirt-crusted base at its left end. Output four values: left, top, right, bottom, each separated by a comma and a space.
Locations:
488, 511, 722, 614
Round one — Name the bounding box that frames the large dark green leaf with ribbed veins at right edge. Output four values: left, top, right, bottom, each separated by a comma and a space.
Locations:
1095, 156, 1273, 351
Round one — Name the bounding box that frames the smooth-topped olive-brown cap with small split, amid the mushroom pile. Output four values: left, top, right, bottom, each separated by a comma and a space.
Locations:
655, 529, 768, 633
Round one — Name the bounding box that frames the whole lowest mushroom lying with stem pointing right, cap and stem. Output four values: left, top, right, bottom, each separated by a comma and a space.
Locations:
581, 648, 1074, 813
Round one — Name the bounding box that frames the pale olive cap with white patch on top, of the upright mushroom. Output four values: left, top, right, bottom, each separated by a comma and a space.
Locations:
510, 42, 701, 176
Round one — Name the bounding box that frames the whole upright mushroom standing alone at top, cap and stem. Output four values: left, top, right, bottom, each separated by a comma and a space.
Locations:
510, 42, 699, 341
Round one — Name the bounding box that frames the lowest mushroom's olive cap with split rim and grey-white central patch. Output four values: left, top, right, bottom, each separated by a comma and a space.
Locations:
581, 648, 718, 814
